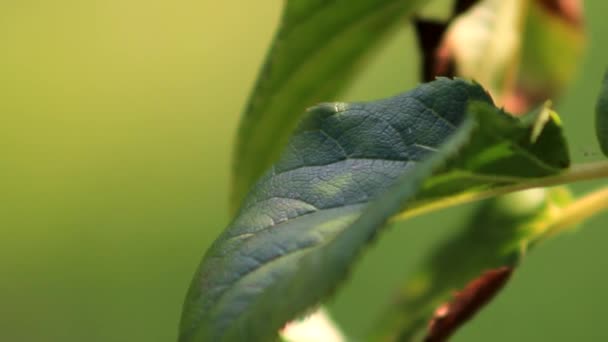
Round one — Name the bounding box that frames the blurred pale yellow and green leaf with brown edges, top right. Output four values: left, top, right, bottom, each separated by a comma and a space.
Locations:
441, 0, 585, 114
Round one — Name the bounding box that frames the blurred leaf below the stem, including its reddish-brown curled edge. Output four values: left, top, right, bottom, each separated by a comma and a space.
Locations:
373, 187, 571, 342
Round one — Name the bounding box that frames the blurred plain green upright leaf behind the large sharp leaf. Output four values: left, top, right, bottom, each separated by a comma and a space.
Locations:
231, 0, 426, 209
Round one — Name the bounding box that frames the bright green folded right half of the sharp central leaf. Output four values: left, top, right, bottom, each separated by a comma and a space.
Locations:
405, 102, 570, 211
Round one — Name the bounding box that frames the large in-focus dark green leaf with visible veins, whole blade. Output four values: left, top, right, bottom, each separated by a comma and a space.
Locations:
180, 79, 568, 342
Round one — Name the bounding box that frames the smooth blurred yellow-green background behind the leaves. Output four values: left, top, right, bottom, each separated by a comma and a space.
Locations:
0, 0, 608, 342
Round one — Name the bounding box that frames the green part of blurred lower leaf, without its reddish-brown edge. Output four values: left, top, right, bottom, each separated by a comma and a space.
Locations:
372, 187, 571, 341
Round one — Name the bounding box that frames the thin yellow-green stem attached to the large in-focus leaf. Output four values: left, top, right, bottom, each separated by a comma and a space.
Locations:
393, 161, 608, 220
